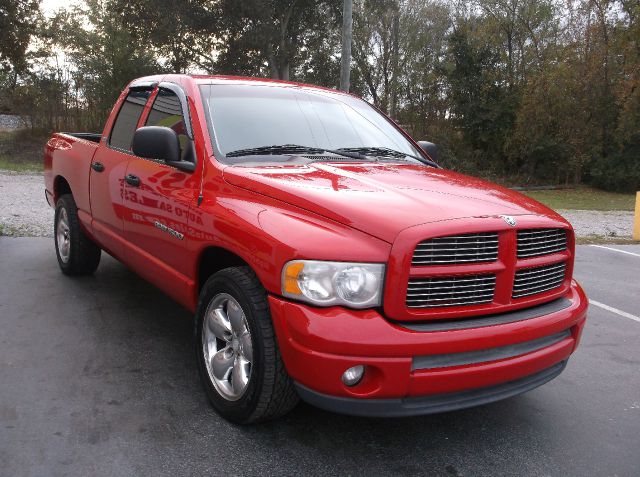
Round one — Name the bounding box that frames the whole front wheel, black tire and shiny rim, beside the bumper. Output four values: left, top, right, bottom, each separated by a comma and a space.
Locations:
194, 267, 298, 424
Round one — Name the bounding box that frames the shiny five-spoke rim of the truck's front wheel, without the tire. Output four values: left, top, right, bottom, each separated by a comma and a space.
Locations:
202, 293, 253, 401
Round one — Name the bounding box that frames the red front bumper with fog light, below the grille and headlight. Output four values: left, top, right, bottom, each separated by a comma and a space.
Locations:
269, 282, 588, 416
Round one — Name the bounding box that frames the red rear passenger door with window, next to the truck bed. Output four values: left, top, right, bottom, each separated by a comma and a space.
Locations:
89, 87, 152, 258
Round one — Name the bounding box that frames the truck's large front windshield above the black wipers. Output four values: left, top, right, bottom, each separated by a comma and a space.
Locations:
200, 84, 423, 162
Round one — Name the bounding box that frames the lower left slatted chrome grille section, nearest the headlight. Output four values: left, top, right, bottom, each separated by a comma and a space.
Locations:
406, 275, 496, 308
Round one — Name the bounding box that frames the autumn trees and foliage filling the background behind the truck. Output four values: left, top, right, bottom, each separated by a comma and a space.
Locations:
0, 0, 640, 190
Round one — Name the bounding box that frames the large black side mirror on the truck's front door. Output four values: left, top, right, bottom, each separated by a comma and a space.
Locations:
131, 126, 196, 172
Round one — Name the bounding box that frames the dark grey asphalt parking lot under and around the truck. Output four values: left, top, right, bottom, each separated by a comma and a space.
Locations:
0, 237, 640, 476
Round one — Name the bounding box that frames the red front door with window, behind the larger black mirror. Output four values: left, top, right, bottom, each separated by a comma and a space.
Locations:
124, 83, 200, 301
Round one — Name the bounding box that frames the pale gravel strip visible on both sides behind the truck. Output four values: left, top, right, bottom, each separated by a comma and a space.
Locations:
0, 171, 633, 241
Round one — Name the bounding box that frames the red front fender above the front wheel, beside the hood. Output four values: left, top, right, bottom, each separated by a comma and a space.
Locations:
190, 197, 391, 295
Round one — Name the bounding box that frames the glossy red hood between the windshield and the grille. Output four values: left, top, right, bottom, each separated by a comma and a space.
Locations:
224, 162, 563, 243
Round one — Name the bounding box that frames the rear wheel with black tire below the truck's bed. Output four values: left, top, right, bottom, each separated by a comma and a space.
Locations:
53, 194, 102, 275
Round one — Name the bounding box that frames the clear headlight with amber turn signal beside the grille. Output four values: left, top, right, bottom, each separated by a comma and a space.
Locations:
282, 260, 384, 308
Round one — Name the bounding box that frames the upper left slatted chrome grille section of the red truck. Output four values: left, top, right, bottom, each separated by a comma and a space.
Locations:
411, 233, 498, 266
